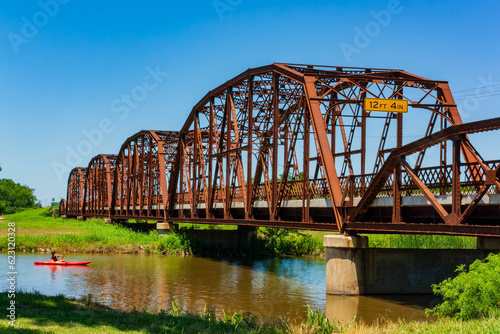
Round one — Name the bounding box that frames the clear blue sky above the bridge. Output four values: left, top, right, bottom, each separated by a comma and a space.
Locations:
0, 0, 500, 204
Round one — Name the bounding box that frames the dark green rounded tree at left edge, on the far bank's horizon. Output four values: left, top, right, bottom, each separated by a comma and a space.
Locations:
0, 179, 36, 215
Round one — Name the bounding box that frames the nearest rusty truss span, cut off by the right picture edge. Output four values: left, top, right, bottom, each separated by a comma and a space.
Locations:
346, 118, 500, 236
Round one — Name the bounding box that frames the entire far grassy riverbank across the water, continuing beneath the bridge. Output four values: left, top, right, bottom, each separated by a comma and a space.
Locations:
0, 208, 476, 257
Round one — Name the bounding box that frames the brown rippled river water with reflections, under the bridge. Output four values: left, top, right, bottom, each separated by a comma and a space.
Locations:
0, 253, 436, 323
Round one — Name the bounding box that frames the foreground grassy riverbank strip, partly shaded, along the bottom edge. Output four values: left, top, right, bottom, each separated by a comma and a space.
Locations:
0, 292, 500, 334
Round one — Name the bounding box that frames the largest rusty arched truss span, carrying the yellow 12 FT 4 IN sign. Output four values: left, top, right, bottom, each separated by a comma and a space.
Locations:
168, 64, 494, 231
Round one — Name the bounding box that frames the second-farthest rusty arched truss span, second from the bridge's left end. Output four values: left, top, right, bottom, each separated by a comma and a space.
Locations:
84, 154, 117, 217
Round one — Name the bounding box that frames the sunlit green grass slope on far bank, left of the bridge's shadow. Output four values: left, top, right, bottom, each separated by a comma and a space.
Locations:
0, 209, 190, 254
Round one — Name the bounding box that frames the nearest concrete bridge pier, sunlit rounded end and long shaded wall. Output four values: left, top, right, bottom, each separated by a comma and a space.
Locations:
323, 235, 500, 295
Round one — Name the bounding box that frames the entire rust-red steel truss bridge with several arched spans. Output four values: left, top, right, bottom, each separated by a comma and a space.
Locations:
60, 63, 500, 236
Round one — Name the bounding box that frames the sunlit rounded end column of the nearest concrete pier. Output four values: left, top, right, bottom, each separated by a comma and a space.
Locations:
323, 234, 368, 295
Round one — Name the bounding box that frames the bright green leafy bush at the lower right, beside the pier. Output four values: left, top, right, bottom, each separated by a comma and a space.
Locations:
428, 254, 500, 320
